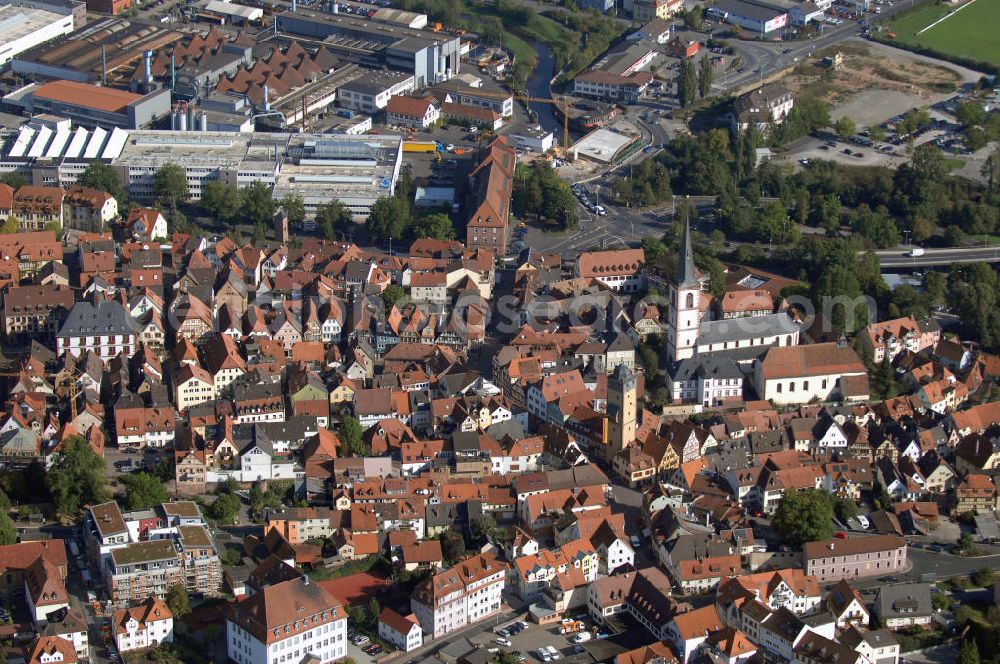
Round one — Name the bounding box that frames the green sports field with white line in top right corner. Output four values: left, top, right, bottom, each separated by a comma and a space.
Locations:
888, 0, 1000, 65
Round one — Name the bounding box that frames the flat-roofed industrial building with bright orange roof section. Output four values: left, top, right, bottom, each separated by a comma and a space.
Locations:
4, 81, 170, 129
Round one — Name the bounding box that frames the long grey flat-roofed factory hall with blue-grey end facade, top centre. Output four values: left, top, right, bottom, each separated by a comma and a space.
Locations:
277, 9, 461, 88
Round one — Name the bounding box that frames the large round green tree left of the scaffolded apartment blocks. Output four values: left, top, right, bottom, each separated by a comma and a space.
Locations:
46, 436, 111, 517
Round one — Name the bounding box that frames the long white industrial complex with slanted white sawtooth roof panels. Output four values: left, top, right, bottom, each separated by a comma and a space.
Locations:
0, 122, 403, 221
